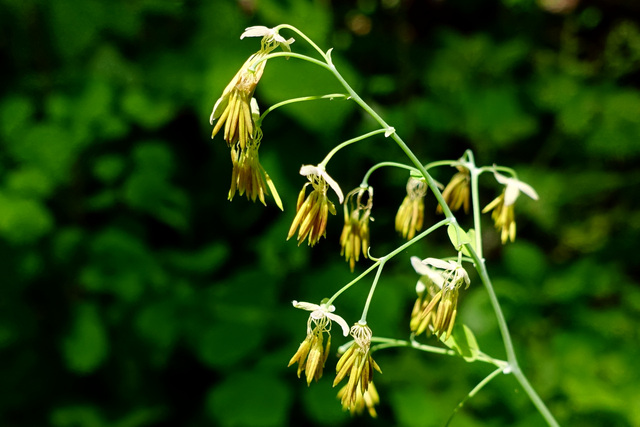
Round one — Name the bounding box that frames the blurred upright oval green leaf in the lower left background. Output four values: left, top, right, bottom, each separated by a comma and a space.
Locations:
62, 303, 109, 374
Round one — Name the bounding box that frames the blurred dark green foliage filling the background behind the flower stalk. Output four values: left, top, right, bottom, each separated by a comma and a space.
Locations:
0, 0, 640, 427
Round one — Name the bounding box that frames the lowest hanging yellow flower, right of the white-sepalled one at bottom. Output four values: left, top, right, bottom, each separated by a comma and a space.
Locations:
333, 322, 382, 411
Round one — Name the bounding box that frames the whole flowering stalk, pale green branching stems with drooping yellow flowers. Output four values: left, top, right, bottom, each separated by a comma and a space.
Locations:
218, 24, 558, 426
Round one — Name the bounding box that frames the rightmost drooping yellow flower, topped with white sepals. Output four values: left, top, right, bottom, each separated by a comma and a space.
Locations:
482, 171, 538, 244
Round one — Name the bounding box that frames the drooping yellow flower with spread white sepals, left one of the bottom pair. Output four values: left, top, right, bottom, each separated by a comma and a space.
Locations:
287, 301, 349, 385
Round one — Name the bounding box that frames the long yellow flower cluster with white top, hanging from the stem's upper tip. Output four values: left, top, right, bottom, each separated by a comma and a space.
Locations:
209, 26, 294, 210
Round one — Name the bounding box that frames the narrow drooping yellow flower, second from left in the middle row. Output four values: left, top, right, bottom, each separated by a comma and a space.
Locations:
340, 187, 373, 271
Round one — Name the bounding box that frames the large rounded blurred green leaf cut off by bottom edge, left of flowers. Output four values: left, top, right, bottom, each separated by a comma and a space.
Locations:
206, 371, 292, 427
